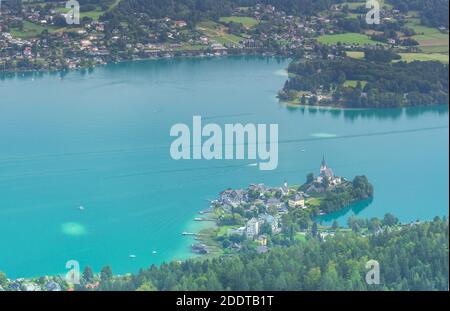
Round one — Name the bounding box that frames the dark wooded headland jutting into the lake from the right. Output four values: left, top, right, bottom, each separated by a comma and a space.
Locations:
280, 53, 449, 108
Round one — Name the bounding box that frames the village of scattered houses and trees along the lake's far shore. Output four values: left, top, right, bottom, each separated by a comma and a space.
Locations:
0, 0, 448, 72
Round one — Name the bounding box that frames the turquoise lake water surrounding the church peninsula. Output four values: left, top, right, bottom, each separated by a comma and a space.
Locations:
0, 57, 449, 277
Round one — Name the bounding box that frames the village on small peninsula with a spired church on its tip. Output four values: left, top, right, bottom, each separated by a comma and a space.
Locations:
188, 158, 373, 255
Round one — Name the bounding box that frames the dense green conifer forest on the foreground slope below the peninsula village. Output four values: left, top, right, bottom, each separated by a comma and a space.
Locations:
89, 218, 449, 290
